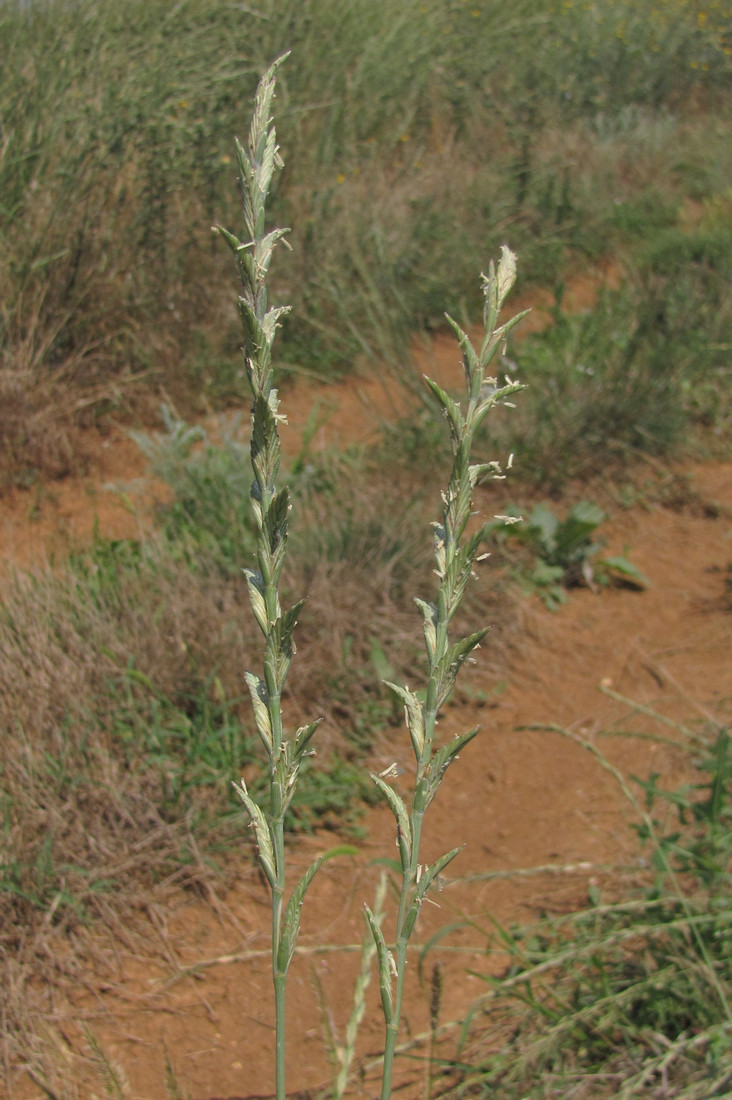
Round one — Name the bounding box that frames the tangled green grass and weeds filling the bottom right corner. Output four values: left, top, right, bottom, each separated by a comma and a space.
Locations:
449, 708, 732, 1100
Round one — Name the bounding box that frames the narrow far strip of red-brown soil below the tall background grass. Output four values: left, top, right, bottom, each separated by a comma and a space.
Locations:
0, 262, 620, 576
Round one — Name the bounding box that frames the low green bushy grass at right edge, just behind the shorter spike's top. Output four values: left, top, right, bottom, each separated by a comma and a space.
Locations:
501, 251, 731, 490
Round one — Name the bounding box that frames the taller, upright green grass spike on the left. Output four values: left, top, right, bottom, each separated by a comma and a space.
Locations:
219, 62, 321, 1100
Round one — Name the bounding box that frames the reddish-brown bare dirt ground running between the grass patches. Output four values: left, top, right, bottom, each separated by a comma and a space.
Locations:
0, 314, 732, 1100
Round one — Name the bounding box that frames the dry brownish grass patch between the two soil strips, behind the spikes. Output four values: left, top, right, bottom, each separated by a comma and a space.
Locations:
0, 437, 517, 1095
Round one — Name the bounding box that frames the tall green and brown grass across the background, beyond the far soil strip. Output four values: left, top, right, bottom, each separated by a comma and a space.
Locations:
0, 0, 732, 484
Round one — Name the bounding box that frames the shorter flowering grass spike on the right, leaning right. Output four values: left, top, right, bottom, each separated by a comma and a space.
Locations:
367, 248, 524, 1100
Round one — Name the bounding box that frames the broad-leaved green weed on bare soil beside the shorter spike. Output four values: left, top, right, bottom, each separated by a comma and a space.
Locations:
492, 501, 648, 611
